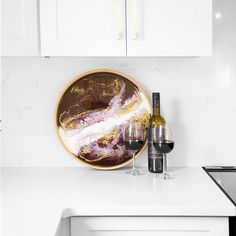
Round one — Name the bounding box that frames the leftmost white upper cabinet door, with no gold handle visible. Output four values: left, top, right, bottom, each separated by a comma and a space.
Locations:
1, 0, 38, 56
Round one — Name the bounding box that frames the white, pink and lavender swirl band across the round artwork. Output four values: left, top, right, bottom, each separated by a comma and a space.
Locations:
59, 79, 150, 162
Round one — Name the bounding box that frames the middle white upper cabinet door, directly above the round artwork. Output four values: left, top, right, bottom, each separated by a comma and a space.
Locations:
40, 0, 126, 56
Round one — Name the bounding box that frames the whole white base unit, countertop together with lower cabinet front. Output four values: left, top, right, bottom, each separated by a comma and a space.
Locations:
1, 167, 236, 236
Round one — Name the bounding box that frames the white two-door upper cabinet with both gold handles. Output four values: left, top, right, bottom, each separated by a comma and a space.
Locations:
40, 0, 212, 56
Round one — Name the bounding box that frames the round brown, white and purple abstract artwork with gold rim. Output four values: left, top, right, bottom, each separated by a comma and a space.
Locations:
55, 70, 151, 170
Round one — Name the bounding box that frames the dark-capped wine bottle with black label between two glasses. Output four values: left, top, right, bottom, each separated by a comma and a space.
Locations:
148, 93, 165, 173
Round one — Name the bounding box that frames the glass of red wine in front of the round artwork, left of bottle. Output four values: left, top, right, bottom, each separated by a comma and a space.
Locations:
123, 120, 147, 176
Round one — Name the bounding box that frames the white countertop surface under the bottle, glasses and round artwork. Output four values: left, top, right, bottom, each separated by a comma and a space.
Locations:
2, 168, 236, 236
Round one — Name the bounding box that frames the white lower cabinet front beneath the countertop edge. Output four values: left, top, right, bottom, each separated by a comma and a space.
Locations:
71, 216, 229, 236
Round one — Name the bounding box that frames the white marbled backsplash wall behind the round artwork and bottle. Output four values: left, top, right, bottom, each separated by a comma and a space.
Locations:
2, 0, 236, 166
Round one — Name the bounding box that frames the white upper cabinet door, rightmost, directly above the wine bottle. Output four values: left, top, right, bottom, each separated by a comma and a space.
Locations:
127, 0, 212, 57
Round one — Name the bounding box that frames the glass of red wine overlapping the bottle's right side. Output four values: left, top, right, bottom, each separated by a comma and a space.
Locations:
153, 124, 174, 180
